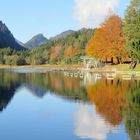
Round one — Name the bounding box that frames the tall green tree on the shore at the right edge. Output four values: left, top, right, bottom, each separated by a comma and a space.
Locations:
123, 0, 140, 65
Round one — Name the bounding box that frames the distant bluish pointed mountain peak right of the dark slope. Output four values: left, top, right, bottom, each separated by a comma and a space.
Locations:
24, 34, 48, 49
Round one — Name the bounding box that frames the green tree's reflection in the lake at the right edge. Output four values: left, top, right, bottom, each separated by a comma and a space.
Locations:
123, 82, 140, 140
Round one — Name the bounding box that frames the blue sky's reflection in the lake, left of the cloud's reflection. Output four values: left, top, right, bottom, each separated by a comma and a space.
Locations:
0, 87, 81, 140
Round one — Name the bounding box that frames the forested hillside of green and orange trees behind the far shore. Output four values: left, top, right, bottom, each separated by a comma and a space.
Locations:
27, 28, 95, 65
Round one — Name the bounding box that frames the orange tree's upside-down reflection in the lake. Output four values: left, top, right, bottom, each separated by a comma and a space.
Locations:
86, 79, 133, 125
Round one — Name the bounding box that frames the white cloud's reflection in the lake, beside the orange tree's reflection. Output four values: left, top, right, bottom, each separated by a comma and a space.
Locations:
75, 105, 129, 140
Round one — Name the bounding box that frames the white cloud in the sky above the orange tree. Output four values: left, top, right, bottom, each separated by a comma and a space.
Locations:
74, 0, 119, 27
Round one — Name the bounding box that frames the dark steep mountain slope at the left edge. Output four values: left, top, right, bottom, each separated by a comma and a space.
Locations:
0, 21, 25, 50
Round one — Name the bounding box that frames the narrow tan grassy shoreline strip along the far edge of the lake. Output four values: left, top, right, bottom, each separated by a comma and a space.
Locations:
0, 64, 140, 73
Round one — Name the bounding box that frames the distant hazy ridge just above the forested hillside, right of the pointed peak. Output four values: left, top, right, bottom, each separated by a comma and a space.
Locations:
50, 30, 75, 41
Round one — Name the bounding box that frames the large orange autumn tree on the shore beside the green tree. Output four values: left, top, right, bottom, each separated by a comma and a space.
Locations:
86, 15, 126, 62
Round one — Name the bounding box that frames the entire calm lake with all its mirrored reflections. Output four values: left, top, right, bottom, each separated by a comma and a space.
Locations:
0, 69, 140, 140
